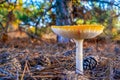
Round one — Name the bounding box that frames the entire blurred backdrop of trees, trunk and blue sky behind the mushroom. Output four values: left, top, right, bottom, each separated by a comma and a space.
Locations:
0, 0, 120, 42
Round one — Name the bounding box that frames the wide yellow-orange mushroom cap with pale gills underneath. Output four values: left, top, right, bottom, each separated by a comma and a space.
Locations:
51, 25, 104, 39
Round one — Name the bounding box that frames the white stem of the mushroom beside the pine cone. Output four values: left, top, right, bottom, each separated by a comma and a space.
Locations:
75, 39, 83, 74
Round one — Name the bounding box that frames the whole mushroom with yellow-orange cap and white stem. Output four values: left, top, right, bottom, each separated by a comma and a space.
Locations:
51, 25, 104, 74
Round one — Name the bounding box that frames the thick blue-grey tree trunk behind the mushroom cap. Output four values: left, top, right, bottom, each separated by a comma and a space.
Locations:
56, 0, 72, 42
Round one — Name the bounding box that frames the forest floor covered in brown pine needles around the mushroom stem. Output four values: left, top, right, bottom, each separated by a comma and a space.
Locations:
0, 38, 120, 80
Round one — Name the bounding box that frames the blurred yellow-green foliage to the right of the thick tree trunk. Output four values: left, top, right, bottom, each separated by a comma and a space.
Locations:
74, 0, 120, 39
